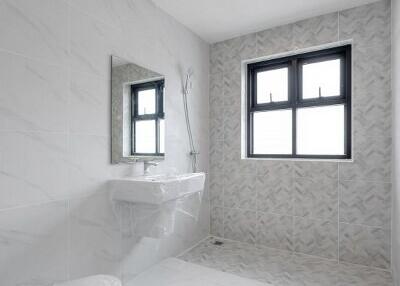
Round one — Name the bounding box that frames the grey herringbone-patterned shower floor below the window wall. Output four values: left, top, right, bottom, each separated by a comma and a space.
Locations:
179, 238, 393, 286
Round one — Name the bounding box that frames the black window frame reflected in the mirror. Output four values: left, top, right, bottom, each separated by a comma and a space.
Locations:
131, 80, 165, 157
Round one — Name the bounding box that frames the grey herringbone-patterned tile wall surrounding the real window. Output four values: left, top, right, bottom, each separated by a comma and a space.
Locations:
210, 0, 392, 268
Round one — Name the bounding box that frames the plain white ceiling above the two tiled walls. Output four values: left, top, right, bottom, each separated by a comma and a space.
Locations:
152, 0, 376, 43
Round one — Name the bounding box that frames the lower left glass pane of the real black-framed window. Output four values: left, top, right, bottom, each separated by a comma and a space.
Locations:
253, 109, 292, 154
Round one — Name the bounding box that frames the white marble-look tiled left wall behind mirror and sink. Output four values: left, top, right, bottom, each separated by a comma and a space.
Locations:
0, 0, 211, 285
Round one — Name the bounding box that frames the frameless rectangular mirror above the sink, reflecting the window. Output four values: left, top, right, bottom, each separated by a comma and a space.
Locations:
111, 56, 165, 164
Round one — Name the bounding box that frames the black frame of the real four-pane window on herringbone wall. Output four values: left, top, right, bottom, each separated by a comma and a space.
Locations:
246, 45, 352, 159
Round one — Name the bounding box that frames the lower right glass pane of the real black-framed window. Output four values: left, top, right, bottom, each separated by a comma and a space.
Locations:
297, 105, 344, 155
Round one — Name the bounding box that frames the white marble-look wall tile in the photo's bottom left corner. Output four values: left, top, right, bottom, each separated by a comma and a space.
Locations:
0, 202, 68, 286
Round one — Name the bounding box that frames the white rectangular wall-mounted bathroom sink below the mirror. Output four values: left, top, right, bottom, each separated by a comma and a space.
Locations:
111, 173, 205, 205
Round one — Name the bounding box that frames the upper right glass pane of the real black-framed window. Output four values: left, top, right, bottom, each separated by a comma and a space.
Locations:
302, 59, 340, 99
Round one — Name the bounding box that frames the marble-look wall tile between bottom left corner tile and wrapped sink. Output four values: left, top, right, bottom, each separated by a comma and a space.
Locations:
69, 192, 121, 279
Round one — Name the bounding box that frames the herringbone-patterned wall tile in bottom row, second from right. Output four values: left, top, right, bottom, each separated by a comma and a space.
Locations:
294, 217, 338, 259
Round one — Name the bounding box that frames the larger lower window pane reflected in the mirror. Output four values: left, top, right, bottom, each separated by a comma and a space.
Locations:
135, 120, 156, 153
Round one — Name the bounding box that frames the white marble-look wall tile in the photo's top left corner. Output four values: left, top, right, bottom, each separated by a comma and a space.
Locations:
0, 0, 69, 66
